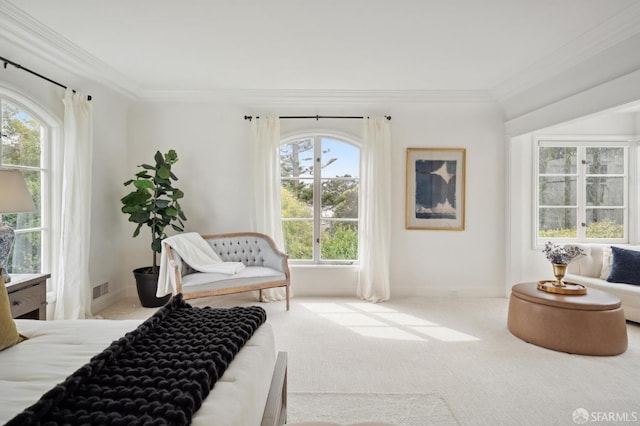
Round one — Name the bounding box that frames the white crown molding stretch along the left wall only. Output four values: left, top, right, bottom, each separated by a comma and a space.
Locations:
0, 0, 137, 99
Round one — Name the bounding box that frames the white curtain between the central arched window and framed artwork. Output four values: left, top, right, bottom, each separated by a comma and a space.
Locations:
358, 117, 391, 303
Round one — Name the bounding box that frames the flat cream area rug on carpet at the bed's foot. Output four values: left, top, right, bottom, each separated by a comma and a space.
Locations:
287, 392, 458, 426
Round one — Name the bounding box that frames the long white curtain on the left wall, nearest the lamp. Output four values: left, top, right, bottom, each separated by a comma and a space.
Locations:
52, 89, 93, 319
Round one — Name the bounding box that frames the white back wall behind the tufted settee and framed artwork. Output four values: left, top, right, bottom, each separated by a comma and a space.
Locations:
122, 102, 505, 295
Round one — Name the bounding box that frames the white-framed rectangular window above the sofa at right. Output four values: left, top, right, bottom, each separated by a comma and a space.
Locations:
535, 139, 629, 244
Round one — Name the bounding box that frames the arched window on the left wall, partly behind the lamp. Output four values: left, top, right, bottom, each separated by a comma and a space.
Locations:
0, 93, 50, 274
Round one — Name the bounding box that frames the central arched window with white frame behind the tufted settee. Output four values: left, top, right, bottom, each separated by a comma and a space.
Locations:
280, 134, 360, 264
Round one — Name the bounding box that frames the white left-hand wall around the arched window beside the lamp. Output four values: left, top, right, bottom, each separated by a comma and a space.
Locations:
0, 52, 129, 313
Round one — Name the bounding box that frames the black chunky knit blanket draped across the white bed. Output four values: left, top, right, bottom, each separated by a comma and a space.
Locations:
7, 294, 266, 426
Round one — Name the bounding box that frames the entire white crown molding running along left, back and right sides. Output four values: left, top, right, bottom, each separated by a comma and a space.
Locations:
10, 0, 640, 105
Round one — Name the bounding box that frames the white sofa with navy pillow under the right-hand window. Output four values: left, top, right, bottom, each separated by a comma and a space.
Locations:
565, 244, 640, 323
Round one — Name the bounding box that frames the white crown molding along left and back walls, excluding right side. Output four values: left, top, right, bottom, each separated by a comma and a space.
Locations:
0, 0, 495, 105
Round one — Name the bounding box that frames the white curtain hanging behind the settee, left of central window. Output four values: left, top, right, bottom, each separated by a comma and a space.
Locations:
251, 117, 286, 302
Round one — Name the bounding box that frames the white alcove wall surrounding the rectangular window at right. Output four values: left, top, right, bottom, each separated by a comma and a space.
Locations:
505, 112, 640, 294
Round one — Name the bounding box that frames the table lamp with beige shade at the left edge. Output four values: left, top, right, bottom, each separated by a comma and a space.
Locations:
0, 170, 35, 282
